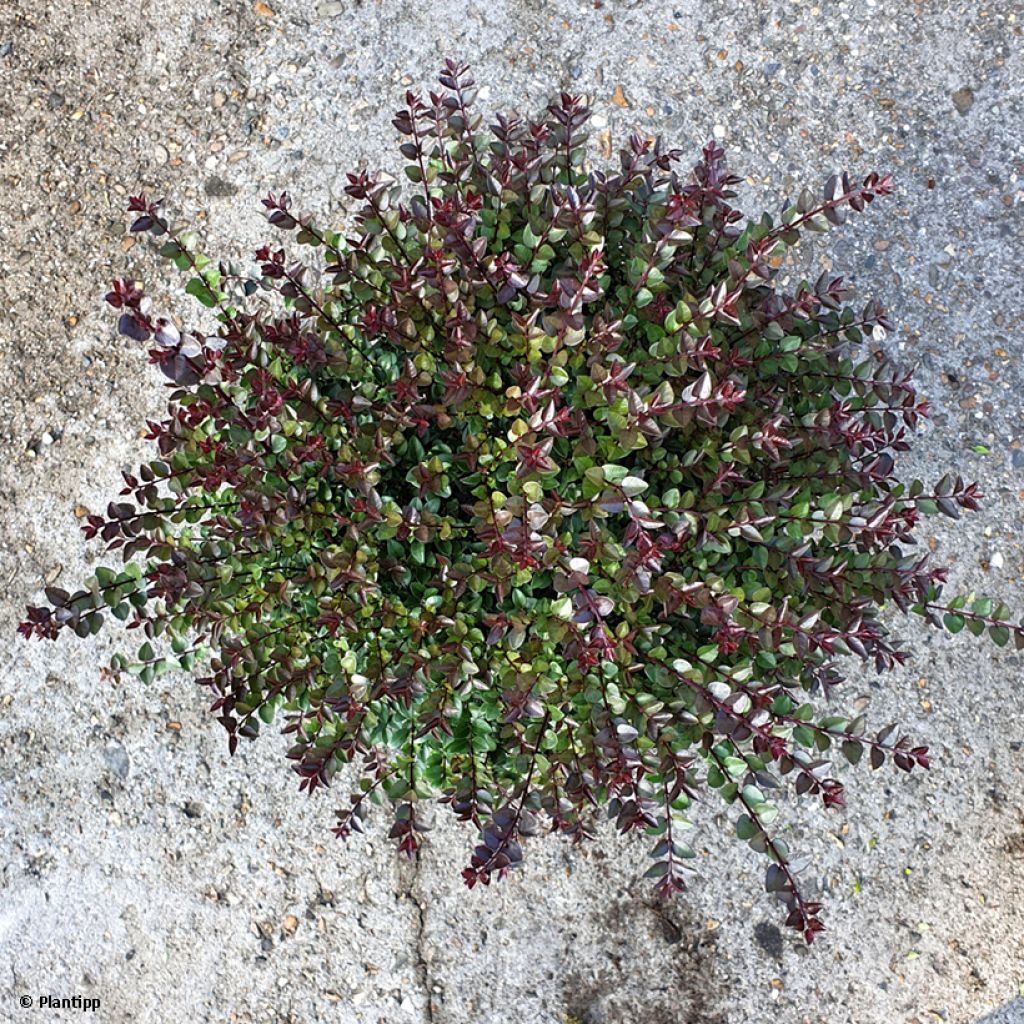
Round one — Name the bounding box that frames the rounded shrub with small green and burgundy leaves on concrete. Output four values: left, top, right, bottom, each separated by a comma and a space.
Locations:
20, 62, 1024, 942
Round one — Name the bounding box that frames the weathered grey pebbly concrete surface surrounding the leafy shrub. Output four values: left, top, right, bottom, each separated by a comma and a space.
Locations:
0, 0, 1024, 1024
